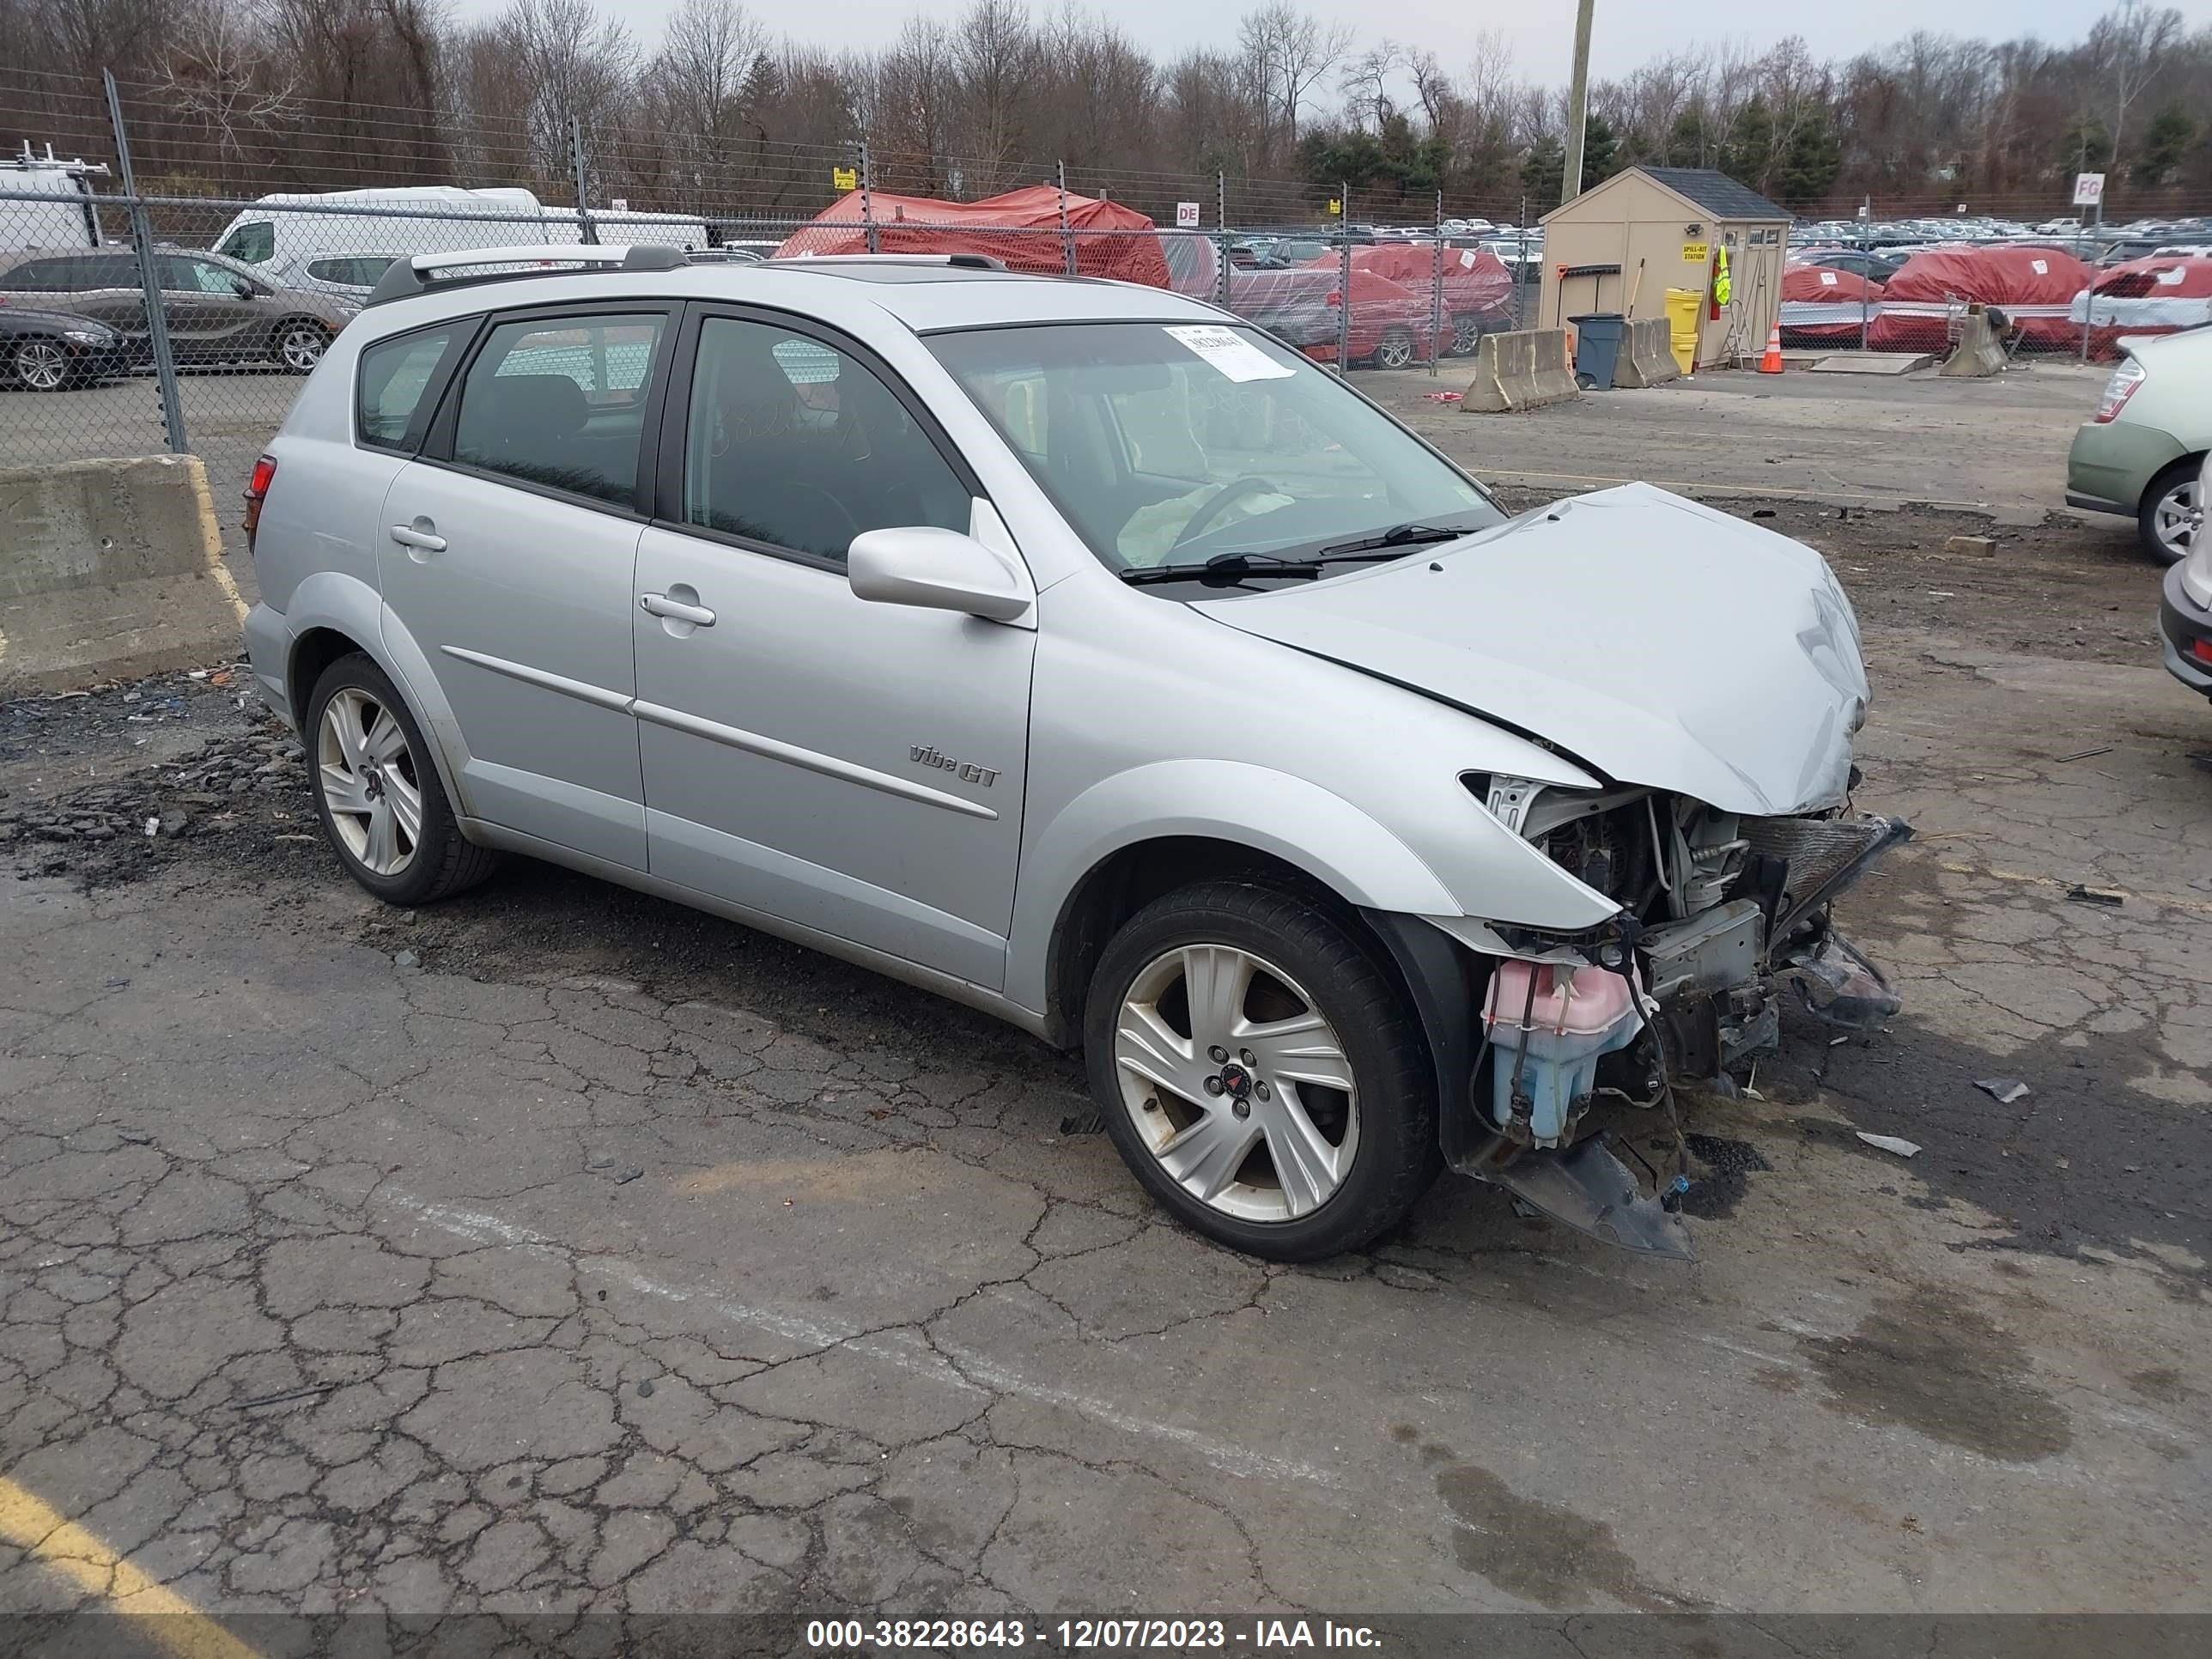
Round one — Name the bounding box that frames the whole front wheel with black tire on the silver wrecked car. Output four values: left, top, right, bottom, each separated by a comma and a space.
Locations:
1084, 880, 1443, 1261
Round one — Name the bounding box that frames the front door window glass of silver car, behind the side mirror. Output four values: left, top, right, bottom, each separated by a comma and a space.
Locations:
684, 316, 973, 564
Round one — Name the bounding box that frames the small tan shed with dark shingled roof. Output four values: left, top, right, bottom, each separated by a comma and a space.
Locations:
1535, 168, 1790, 369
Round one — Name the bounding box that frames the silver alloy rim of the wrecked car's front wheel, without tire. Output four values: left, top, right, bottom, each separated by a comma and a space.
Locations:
1113, 945, 1360, 1221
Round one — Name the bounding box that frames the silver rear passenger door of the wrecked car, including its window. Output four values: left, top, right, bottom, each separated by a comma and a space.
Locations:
376, 303, 672, 869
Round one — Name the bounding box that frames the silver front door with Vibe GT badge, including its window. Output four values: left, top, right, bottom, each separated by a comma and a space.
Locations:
633, 312, 1036, 988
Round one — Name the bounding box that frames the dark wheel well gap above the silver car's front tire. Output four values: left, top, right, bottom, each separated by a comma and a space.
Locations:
1046, 836, 1405, 1046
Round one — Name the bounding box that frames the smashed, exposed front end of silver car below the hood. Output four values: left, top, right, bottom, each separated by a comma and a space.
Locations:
1437, 779, 1911, 1259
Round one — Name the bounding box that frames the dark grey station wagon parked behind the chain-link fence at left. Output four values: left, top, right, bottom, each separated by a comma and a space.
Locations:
0, 248, 358, 374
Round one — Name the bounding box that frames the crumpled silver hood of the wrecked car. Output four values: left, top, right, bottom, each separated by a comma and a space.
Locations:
1194, 484, 1867, 817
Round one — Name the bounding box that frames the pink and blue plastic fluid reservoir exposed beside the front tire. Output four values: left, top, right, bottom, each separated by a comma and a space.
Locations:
1482, 960, 1644, 1146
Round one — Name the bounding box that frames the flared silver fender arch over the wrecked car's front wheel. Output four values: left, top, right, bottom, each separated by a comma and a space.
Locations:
1006, 761, 1460, 1011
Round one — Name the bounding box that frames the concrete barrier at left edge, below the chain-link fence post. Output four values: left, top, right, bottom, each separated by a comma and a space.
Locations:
0, 456, 246, 695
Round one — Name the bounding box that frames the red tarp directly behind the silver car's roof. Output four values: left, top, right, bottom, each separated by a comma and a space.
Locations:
776, 184, 1168, 288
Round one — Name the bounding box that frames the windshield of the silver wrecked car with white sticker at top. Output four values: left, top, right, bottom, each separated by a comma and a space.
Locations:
929, 323, 1504, 580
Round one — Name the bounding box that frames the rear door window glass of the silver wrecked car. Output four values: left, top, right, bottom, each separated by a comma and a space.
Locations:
453, 316, 665, 507
